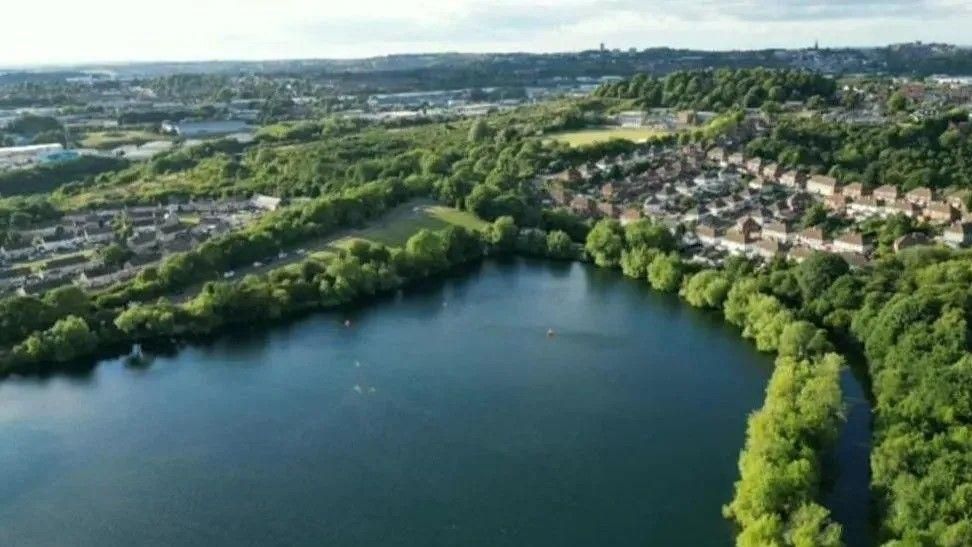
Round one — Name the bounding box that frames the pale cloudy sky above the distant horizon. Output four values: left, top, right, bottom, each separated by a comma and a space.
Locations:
0, 0, 972, 66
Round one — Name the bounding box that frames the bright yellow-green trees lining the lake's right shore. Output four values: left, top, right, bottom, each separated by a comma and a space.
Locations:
585, 220, 846, 547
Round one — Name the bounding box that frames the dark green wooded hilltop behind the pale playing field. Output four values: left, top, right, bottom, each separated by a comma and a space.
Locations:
594, 68, 837, 111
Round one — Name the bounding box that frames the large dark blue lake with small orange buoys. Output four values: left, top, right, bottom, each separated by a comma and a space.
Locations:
0, 261, 860, 546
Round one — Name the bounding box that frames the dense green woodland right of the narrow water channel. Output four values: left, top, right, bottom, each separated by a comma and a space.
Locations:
850, 248, 972, 547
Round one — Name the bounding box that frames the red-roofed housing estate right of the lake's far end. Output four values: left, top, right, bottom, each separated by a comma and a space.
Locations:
543, 141, 972, 267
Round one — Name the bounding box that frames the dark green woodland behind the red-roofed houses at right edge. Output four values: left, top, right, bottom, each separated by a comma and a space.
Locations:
746, 111, 972, 190
